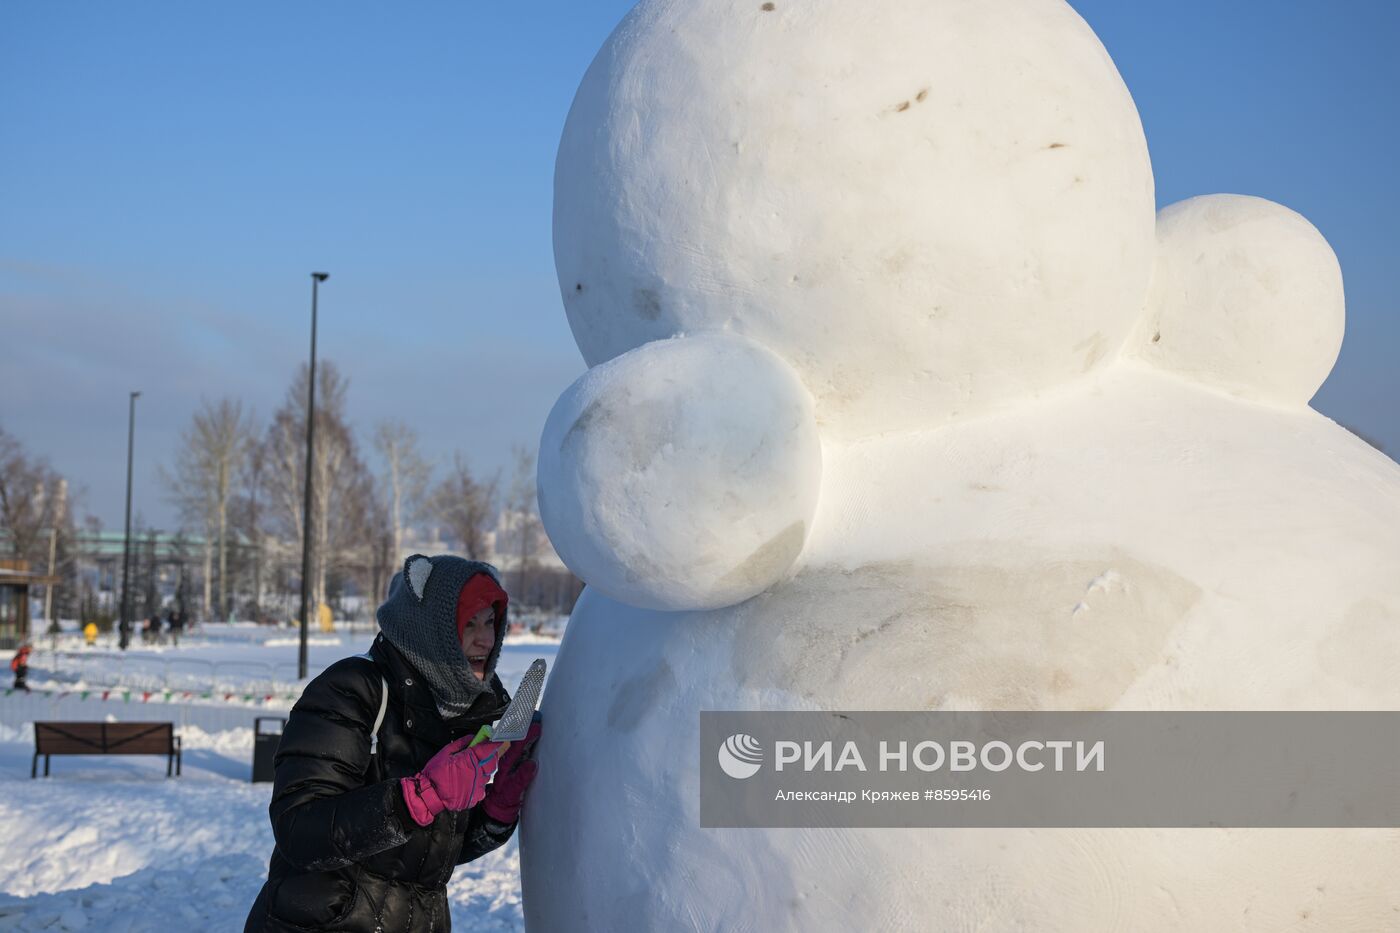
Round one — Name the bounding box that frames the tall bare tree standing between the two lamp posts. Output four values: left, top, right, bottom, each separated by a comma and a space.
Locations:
161, 398, 253, 619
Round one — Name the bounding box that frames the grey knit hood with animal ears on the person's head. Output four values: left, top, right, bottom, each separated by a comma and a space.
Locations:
374, 553, 507, 717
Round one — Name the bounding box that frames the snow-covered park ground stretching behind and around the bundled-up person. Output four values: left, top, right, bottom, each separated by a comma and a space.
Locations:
0, 628, 557, 933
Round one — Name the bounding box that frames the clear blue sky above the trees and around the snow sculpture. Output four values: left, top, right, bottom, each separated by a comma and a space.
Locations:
0, 0, 1400, 527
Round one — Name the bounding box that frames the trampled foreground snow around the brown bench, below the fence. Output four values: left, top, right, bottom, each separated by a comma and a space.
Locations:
0, 733, 524, 933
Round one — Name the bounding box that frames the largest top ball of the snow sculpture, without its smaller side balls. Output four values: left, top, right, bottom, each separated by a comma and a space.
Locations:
554, 0, 1154, 438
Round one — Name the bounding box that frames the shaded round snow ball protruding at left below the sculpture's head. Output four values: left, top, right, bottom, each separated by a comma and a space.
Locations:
539, 333, 822, 609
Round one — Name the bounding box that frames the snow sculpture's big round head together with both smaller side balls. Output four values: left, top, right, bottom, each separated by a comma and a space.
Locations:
539, 0, 1341, 609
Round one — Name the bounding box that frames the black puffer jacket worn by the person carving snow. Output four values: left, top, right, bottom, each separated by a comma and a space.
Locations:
245, 635, 515, 933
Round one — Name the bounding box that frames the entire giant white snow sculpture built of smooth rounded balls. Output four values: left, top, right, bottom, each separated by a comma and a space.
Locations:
522, 0, 1400, 932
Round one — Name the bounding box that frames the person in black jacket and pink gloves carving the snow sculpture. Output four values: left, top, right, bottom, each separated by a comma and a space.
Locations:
244, 555, 539, 933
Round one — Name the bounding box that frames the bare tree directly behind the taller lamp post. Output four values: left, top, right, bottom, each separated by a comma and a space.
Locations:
266, 360, 372, 607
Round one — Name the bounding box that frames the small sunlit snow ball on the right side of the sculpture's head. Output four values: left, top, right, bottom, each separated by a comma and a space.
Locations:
1128, 195, 1345, 405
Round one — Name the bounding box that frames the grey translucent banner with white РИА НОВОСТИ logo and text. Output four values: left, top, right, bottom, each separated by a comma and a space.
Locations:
700, 712, 1400, 827
